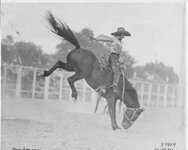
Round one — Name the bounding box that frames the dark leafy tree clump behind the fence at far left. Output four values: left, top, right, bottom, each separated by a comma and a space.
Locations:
1, 35, 48, 67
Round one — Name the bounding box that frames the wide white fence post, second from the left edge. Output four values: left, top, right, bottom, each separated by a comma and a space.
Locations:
16, 66, 22, 97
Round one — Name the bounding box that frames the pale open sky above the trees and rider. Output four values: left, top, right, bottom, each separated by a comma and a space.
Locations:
1, 2, 185, 75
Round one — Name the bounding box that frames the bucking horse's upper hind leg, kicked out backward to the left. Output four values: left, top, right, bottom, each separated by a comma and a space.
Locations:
40, 60, 74, 77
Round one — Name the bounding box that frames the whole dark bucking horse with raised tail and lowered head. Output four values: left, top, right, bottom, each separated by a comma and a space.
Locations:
41, 12, 143, 130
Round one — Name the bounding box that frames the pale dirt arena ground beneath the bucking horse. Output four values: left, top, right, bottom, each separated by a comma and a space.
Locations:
1, 98, 186, 150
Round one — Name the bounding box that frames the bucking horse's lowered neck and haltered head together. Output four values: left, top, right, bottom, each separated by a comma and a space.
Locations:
121, 78, 144, 129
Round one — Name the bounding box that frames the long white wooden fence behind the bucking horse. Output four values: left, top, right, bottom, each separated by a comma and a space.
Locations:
1, 64, 184, 107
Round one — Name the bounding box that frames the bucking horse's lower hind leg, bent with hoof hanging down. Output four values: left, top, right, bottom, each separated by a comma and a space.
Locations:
67, 72, 84, 100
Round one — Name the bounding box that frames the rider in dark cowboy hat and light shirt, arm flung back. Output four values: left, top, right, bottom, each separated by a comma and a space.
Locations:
90, 27, 131, 92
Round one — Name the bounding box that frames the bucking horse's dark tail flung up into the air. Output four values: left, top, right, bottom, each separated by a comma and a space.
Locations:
46, 11, 80, 49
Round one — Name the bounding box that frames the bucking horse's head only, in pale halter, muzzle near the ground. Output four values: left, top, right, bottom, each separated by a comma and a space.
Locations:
121, 108, 144, 129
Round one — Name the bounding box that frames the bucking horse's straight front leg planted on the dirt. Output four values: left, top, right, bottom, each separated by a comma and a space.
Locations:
107, 93, 121, 130
